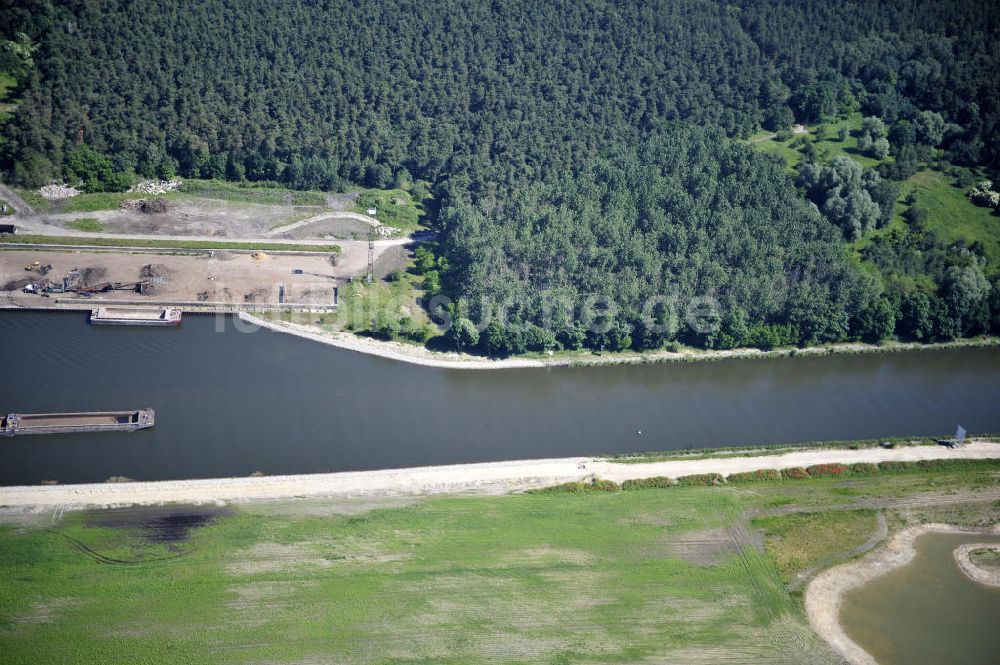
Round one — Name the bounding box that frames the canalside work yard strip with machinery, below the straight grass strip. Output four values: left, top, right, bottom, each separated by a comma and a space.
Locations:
0, 248, 405, 310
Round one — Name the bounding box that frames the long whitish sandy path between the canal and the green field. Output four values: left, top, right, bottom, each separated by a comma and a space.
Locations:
0, 441, 1000, 508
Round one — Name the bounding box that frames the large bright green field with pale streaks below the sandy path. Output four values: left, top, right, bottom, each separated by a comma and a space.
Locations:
0, 468, 1000, 664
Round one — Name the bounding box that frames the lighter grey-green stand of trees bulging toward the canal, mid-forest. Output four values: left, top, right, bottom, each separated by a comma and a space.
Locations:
441, 129, 880, 355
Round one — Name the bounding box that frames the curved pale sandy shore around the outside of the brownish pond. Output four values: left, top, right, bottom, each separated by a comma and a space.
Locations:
805, 524, 1000, 665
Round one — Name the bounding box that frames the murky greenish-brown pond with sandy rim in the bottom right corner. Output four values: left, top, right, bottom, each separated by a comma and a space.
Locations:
840, 533, 1000, 665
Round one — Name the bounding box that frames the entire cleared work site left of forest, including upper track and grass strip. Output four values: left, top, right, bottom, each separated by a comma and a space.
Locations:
0, 181, 415, 311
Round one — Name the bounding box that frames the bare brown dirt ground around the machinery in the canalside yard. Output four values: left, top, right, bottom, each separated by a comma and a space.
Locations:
0, 250, 345, 307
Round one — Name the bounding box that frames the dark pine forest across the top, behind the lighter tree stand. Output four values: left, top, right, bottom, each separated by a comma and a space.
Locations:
0, 0, 1000, 192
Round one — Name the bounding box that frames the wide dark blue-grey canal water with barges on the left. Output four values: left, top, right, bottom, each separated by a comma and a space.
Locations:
0, 312, 1000, 485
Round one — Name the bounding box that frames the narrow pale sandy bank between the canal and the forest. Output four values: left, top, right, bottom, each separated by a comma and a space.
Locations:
236, 312, 1000, 369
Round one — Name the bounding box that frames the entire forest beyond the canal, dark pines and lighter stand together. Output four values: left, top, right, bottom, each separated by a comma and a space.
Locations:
0, 0, 1000, 353
